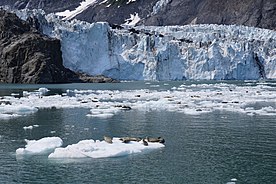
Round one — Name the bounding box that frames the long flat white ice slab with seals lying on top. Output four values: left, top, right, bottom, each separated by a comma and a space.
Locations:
49, 138, 165, 158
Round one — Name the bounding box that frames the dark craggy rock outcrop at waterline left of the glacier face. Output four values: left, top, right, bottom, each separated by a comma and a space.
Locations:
0, 10, 116, 83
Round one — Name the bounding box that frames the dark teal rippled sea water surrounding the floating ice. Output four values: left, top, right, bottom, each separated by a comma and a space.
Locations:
0, 81, 276, 184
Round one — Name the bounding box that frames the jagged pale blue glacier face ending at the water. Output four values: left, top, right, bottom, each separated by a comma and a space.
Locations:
14, 10, 276, 80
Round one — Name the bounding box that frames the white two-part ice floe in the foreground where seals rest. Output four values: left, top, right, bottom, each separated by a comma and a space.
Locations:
16, 137, 165, 159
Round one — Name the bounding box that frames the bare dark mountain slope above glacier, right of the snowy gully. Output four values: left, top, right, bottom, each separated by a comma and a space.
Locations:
144, 0, 276, 29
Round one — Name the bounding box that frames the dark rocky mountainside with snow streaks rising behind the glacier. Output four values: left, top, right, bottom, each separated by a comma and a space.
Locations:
0, 0, 276, 30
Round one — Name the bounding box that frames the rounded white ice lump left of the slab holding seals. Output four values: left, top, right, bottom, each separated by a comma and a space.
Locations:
16, 137, 63, 155
